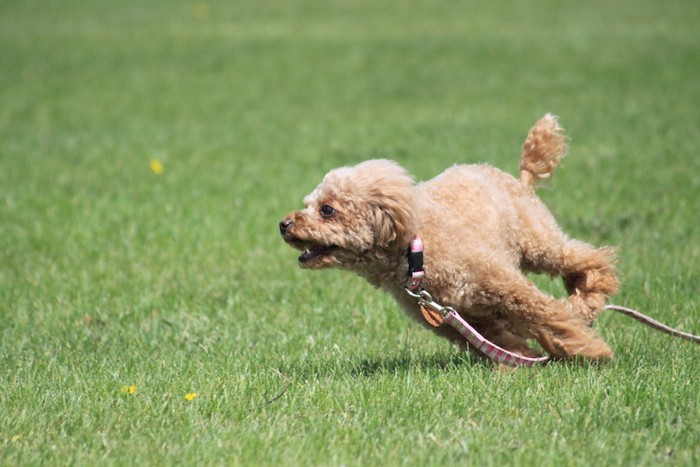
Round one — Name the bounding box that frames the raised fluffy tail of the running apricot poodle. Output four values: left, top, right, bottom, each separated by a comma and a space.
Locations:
520, 114, 568, 188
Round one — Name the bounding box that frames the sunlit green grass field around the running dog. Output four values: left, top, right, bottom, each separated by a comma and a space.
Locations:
0, 0, 700, 466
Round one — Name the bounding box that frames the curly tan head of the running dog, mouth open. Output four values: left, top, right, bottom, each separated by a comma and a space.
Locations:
279, 160, 416, 270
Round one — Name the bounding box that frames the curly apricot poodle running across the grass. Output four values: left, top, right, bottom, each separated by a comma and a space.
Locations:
279, 114, 619, 360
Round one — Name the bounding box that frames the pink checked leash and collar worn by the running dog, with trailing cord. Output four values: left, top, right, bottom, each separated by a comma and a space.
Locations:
404, 235, 700, 367
